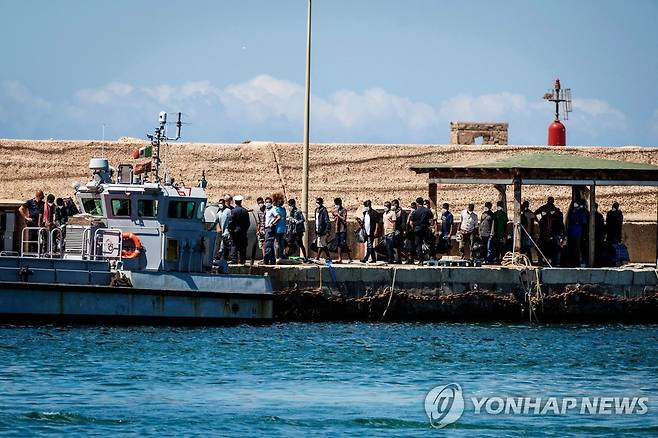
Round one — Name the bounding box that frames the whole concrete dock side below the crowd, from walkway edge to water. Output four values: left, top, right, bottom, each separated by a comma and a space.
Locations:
231, 263, 658, 324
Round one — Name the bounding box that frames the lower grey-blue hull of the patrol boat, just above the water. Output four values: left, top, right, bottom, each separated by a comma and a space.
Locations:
0, 282, 273, 325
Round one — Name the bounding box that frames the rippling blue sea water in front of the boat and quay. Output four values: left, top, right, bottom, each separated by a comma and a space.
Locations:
0, 323, 658, 437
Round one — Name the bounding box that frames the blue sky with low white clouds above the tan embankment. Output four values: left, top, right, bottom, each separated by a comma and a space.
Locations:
0, 0, 658, 146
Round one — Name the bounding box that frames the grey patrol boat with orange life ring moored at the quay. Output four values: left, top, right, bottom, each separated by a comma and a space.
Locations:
0, 112, 273, 325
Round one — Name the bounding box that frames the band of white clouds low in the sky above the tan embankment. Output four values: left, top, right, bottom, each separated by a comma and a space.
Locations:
0, 74, 632, 144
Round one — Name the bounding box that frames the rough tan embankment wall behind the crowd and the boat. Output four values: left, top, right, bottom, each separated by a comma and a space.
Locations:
0, 139, 658, 220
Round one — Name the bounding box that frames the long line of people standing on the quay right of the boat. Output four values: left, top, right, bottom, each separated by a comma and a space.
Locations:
210, 194, 623, 266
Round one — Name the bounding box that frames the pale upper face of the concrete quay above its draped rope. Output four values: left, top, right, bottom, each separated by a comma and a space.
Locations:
231, 263, 658, 298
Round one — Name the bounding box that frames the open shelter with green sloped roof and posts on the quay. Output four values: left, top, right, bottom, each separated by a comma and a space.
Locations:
410, 151, 658, 265
